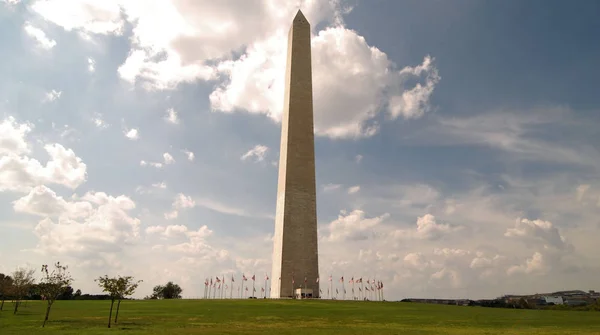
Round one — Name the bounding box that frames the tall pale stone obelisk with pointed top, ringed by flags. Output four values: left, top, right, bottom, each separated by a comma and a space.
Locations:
271, 11, 319, 298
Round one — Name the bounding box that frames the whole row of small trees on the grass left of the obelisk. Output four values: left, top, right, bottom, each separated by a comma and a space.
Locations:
0, 262, 183, 328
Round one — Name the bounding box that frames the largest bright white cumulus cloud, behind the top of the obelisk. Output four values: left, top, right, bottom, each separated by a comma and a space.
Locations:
32, 0, 440, 138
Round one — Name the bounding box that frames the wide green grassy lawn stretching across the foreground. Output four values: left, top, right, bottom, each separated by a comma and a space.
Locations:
0, 300, 600, 335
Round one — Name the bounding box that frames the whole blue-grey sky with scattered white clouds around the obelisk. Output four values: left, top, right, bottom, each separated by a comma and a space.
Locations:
0, 0, 600, 300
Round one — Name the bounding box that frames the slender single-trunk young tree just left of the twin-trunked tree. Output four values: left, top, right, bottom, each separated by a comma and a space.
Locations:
38, 262, 73, 327
